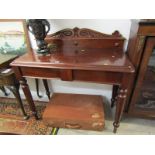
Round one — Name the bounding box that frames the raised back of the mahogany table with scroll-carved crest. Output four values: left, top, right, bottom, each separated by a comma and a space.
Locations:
45, 27, 125, 53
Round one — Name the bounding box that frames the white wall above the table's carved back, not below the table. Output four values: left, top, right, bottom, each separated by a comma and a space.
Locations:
30, 19, 131, 48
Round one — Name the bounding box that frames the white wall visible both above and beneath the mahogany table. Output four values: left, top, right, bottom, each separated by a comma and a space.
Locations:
0, 19, 131, 101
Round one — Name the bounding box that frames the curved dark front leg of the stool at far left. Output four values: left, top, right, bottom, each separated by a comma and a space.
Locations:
8, 85, 29, 120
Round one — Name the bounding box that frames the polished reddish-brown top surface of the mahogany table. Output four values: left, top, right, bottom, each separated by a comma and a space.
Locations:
11, 49, 134, 73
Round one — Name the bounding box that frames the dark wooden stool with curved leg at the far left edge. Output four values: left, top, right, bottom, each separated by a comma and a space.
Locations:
0, 68, 29, 119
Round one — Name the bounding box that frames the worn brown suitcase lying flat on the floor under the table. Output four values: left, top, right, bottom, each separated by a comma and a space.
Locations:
43, 93, 105, 131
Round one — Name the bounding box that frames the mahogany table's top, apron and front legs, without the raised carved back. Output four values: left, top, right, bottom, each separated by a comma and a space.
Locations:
11, 51, 134, 132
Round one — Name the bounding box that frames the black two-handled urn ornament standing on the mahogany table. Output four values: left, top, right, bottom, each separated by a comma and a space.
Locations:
27, 19, 50, 55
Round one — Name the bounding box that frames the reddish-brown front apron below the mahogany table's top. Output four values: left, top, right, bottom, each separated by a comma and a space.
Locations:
20, 67, 123, 84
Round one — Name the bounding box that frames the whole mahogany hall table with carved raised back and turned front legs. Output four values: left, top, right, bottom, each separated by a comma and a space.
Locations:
11, 28, 134, 132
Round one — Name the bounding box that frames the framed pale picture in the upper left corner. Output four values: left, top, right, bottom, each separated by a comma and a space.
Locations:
0, 19, 31, 56
